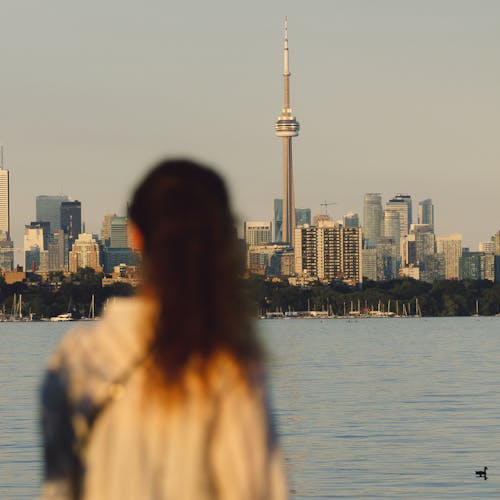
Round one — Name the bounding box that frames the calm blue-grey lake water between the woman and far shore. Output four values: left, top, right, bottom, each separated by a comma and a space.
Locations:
0, 318, 500, 499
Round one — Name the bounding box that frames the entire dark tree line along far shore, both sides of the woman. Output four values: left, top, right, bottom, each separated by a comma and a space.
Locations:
0, 268, 500, 319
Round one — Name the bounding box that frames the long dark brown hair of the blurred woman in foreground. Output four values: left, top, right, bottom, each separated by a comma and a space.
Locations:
129, 159, 261, 386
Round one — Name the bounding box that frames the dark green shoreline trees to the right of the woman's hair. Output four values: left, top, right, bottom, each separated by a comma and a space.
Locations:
246, 276, 500, 316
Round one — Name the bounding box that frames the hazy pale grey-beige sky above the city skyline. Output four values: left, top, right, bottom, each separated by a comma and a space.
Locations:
0, 0, 500, 248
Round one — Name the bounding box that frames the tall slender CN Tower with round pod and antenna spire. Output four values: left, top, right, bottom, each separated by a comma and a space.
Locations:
274, 17, 300, 245
